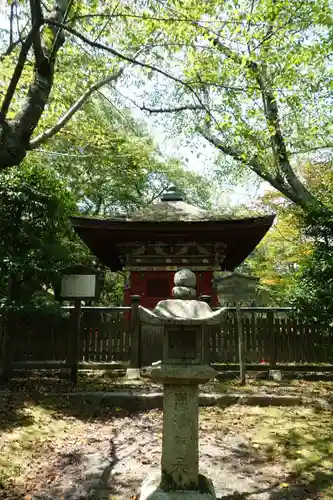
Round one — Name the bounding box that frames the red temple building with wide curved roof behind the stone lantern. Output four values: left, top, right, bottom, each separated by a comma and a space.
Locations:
71, 187, 274, 308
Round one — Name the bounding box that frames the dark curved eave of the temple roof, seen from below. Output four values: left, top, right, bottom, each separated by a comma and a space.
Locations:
71, 215, 275, 271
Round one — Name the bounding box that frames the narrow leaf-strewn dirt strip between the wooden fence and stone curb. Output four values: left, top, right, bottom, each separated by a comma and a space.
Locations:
0, 370, 333, 399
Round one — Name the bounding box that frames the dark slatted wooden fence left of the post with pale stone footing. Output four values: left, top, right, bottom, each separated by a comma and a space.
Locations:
10, 307, 131, 362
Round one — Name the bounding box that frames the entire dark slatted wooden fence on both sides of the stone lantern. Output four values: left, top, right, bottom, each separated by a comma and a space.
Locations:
0, 306, 333, 366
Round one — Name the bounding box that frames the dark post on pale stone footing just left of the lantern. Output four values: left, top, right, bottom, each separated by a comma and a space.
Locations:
126, 295, 141, 379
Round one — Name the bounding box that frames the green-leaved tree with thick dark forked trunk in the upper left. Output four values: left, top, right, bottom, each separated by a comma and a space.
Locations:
0, 0, 156, 168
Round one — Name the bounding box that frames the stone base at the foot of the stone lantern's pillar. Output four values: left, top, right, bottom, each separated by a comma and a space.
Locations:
140, 472, 216, 500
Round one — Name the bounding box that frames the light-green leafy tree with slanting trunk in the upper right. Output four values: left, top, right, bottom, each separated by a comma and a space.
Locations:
118, 0, 333, 211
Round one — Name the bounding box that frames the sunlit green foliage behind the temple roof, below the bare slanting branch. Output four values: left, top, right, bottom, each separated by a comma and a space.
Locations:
38, 98, 210, 217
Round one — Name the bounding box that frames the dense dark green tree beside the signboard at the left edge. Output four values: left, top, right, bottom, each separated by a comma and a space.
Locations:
0, 163, 82, 308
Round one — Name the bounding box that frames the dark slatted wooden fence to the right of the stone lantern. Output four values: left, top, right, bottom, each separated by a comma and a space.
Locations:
209, 308, 333, 365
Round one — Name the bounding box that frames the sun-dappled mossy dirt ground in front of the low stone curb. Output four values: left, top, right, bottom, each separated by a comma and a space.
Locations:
0, 392, 333, 500
